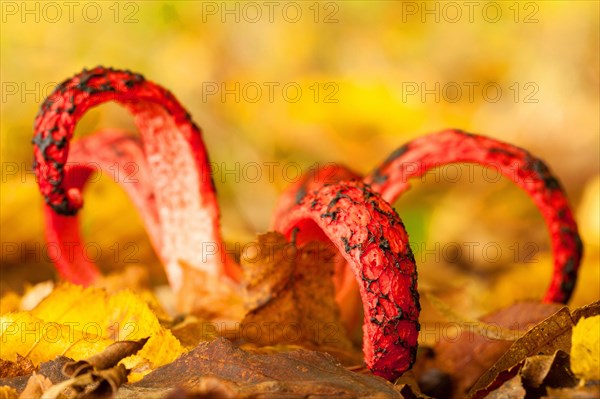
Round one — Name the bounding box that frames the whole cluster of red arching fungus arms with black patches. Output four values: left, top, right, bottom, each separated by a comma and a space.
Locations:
33, 67, 582, 380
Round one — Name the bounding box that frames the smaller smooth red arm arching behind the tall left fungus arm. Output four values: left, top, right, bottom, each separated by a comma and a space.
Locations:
44, 130, 161, 285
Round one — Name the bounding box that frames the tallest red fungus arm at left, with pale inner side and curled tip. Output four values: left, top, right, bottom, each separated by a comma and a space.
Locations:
33, 67, 228, 296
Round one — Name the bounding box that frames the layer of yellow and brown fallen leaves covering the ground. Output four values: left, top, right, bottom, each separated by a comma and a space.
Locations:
0, 239, 599, 398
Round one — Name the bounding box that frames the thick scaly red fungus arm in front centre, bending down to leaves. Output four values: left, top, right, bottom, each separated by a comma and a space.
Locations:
280, 182, 420, 380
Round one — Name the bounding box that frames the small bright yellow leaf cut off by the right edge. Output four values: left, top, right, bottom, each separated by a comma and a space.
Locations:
571, 316, 600, 380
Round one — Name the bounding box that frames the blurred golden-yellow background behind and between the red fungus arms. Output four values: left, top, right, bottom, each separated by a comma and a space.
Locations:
0, 1, 600, 314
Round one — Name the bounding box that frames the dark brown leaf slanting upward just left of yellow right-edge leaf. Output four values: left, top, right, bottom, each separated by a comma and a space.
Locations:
469, 307, 573, 399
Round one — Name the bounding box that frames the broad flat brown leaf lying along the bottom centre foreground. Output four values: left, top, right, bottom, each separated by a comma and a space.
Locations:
117, 338, 402, 398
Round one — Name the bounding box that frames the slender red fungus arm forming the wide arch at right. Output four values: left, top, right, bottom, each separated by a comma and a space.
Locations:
365, 130, 583, 303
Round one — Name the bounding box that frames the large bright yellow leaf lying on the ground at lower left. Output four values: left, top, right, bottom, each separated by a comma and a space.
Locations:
0, 283, 183, 381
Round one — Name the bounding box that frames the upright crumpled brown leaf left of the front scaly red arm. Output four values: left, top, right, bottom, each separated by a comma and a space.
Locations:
241, 233, 352, 351
